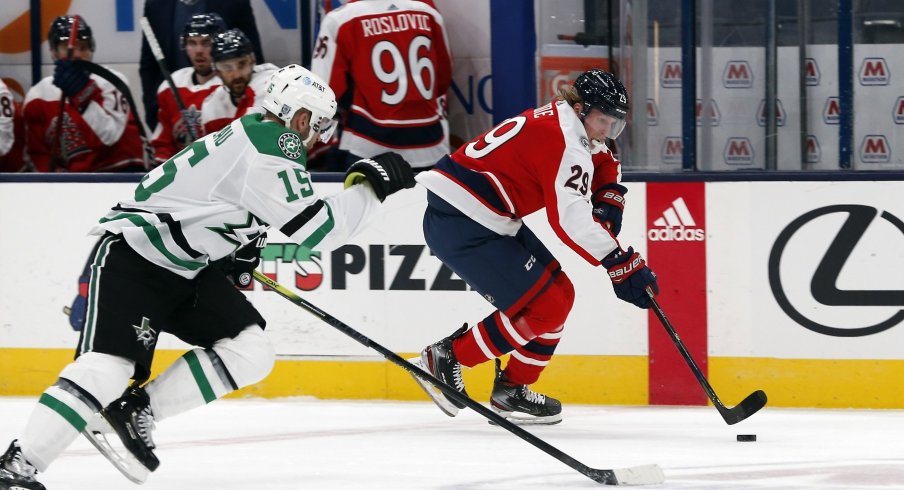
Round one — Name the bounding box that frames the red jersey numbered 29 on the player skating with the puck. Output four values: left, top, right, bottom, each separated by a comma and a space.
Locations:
417, 102, 620, 265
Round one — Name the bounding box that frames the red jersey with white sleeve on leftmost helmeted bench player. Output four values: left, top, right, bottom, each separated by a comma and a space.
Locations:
23, 70, 145, 172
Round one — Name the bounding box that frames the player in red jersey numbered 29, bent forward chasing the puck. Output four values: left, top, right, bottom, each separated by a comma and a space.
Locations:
416, 70, 658, 424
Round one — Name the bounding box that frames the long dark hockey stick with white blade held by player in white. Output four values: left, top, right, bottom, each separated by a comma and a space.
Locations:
254, 270, 664, 485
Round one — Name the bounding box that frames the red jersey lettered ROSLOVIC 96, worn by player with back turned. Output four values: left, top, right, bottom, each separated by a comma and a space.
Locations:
311, 0, 452, 168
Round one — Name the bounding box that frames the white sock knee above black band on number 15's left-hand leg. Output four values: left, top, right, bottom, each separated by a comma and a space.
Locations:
57, 352, 135, 407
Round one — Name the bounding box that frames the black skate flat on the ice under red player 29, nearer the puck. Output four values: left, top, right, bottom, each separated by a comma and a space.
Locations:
490, 359, 562, 425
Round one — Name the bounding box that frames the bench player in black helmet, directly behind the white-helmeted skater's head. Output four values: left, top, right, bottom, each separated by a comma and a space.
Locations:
201, 29, 276, 134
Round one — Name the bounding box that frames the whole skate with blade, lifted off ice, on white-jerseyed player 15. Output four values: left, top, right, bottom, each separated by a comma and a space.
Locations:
82, 387, 160, 483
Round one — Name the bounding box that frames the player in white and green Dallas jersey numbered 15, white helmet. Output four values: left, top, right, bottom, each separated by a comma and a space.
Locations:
0, 65, 414, 490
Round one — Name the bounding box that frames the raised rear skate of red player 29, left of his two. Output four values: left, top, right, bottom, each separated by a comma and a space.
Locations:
409, 323, 468, 417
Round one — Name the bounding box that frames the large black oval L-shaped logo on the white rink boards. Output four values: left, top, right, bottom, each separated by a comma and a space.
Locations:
768, 204, 904, 337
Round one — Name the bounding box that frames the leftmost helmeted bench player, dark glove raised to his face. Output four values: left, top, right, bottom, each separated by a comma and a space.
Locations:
23, 15, 145, 172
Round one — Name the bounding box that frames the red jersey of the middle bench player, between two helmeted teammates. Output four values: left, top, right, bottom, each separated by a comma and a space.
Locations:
151, 66, 222, 163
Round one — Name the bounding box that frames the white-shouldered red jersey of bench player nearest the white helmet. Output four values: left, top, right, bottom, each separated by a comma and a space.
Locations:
201, 63, 279, 134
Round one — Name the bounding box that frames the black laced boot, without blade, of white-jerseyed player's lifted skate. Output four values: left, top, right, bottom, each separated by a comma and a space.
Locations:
101, 386, 160, 471
